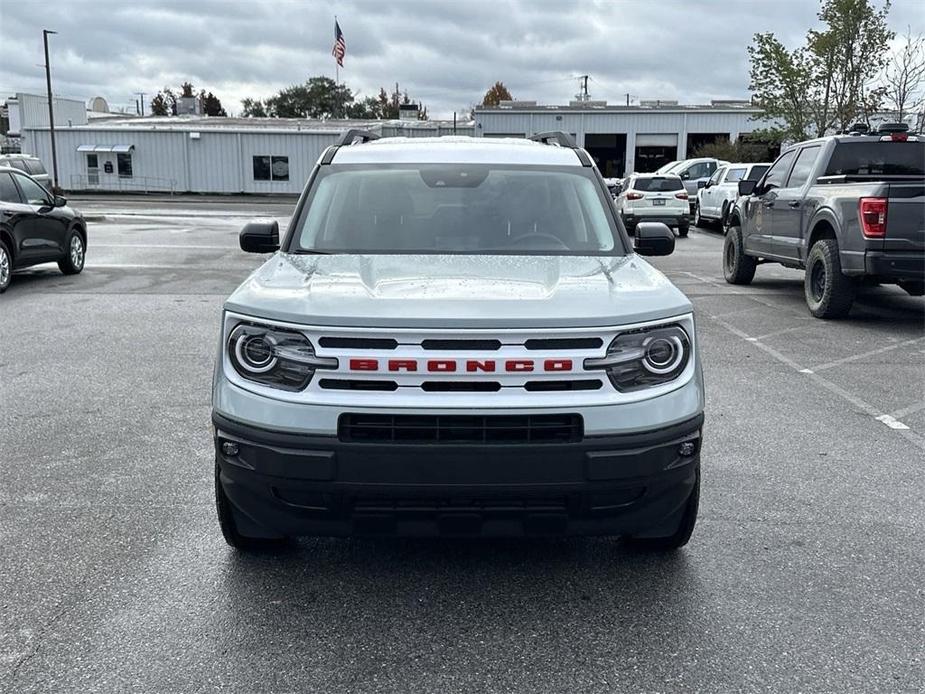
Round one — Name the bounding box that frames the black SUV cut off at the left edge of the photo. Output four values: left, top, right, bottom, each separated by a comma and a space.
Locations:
0, 166, 87, 293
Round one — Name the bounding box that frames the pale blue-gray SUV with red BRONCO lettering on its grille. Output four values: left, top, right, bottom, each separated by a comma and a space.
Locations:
212, 131, 704, 549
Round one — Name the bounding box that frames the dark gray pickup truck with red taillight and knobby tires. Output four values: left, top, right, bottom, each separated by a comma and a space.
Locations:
723, 125, 925, 318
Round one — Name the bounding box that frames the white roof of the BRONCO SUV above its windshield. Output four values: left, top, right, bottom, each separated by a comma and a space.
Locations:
332, 136, 581, 166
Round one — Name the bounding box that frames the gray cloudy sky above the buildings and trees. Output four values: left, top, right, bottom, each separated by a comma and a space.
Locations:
0, 0, 925, 117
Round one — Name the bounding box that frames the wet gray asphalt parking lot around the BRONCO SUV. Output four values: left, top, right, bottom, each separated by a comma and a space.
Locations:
0, 200, 925, 693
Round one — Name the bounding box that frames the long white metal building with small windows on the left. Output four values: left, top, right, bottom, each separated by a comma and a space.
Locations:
22, 116, 474, 194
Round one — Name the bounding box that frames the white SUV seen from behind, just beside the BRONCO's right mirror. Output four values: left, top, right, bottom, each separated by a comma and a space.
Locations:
616, 173, 690, 236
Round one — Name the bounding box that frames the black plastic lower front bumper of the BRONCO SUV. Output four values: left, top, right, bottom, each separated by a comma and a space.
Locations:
213, 414, 703, 537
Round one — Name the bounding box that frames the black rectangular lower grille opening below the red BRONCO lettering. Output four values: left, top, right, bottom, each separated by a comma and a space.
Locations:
337, 413, 584, 444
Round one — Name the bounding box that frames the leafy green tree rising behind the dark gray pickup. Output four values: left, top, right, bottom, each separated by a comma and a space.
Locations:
748, 0, 894, 140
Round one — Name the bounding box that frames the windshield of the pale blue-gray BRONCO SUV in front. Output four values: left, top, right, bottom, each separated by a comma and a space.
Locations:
290, 164, 624, 255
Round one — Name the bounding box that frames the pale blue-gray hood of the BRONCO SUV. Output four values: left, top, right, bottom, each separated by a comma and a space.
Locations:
225, 253, 691, 328
